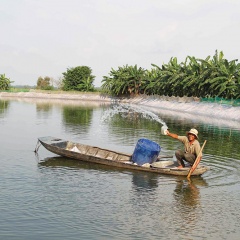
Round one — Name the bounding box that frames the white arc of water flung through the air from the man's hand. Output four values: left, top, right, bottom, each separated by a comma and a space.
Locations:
101, 104, 167, 127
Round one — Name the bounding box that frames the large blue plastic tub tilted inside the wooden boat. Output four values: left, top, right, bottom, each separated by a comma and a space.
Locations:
132, 138, 161, 165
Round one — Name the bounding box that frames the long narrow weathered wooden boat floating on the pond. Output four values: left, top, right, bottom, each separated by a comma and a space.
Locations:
35, 136, 209, 176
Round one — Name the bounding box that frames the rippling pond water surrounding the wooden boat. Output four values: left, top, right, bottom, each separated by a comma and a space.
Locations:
0, 98, 240, 240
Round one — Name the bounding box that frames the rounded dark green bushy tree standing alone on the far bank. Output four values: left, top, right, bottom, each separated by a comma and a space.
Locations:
62, 66, 95, 92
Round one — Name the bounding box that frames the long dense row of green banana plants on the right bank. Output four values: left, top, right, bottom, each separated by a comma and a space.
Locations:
102, 51, 240, 99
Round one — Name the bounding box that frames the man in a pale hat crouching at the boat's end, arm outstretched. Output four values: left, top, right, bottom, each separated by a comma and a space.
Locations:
166, 128, 202, 168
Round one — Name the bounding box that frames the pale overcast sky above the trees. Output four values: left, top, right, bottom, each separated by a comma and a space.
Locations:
0, 0, 240, 87
